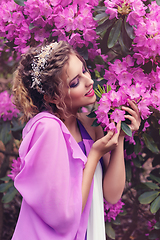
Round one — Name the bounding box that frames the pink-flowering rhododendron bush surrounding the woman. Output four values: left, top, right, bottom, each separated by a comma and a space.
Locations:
0, 0, 160, 240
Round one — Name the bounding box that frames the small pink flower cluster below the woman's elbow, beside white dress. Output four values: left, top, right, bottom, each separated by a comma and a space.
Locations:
104, 199, 124, 222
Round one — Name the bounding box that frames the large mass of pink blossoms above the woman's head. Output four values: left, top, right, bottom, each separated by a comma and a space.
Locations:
0, 0, 98, 58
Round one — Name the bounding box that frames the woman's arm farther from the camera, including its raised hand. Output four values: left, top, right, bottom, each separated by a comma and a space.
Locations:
103, 100, 141, 204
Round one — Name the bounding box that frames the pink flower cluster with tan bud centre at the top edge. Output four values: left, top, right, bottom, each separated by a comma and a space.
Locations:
104, 0, 146, 25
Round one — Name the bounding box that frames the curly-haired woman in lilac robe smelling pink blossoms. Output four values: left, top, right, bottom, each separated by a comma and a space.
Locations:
12, 41, 140, 240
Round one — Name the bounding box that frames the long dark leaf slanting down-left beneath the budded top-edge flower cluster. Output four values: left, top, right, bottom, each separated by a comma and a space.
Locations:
108, 18, 122, 48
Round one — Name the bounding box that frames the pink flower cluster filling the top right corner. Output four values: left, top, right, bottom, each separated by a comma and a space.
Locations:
132, 1, 160, 64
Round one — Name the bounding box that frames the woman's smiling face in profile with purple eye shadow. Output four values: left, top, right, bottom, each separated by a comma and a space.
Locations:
63, 54, 96, 113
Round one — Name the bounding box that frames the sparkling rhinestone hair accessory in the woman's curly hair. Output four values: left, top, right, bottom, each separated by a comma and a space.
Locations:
31, 42, 58, 93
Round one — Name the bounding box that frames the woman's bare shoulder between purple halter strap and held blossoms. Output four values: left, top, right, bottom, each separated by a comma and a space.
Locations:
78, 112, 103, 141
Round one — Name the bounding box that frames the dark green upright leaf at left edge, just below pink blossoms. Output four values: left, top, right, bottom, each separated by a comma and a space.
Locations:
0, 121, 11, 144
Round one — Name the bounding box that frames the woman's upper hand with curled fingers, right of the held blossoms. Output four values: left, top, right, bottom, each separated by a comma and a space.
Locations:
122, 99, 141, 132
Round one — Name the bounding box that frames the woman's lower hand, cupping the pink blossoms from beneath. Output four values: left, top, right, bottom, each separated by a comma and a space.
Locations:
91, 122, 121, 159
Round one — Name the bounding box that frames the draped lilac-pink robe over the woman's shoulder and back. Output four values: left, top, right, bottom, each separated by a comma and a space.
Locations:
12, 112, 93, 240
